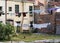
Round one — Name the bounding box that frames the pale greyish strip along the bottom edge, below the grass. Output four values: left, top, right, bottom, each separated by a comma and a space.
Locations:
0, 39, 60, 43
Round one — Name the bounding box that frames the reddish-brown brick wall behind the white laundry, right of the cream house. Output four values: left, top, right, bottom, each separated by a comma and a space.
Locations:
36, 13, 60, 32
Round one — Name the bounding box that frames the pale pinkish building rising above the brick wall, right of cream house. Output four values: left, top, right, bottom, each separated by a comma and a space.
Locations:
35, 0, 48, 14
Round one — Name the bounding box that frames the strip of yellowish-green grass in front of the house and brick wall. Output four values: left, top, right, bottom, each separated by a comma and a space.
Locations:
11, 34, 60, 42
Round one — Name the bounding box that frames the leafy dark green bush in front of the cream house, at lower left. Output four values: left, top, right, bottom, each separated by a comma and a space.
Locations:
0, 23, 14, 40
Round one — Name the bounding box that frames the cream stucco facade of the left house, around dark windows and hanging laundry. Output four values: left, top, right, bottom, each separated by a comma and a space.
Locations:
0, 0, 33, 30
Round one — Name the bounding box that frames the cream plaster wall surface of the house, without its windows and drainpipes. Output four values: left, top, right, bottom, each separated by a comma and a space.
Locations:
0, 0, 33, 29
